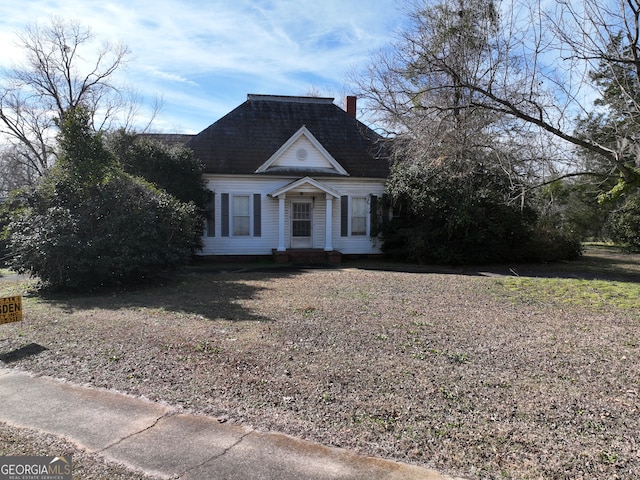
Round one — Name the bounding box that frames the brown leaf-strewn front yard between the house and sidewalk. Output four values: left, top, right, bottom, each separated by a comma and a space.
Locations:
0, 248, 640, 479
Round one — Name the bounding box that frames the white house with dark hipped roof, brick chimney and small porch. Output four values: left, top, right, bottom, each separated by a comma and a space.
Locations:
186, 95, 389, 261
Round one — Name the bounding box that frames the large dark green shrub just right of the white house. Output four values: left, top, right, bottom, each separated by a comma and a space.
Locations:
382, 157, 580, 264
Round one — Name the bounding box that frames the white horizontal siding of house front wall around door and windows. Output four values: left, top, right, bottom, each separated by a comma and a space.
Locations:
201, 174, 384, 255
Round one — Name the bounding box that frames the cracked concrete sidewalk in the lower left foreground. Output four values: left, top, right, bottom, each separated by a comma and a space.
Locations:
0, 368, 470, 480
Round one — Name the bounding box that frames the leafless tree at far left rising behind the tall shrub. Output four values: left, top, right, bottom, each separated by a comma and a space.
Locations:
0, 18, 135, 184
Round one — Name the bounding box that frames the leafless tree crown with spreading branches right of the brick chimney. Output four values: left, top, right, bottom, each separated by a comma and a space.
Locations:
359, 0, 640, 195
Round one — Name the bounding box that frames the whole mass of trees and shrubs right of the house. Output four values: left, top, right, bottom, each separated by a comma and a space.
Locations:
354, 0, 640, 263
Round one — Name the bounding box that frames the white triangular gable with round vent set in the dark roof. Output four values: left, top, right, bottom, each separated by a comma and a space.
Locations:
256, 126, 349, 175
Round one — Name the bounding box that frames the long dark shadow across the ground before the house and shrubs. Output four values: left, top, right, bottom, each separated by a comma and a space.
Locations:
5, 246, 640, 322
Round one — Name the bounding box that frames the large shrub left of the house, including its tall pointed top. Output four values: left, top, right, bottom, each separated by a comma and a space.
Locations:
9, 111, 201, 290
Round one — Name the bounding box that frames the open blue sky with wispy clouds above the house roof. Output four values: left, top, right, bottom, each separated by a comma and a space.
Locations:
0, 0, 403, 133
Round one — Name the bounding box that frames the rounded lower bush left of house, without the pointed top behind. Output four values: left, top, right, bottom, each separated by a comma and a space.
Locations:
10, 175, 199, 290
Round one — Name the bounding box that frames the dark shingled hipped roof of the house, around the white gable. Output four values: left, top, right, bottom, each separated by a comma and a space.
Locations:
187, 95, 389, 178
